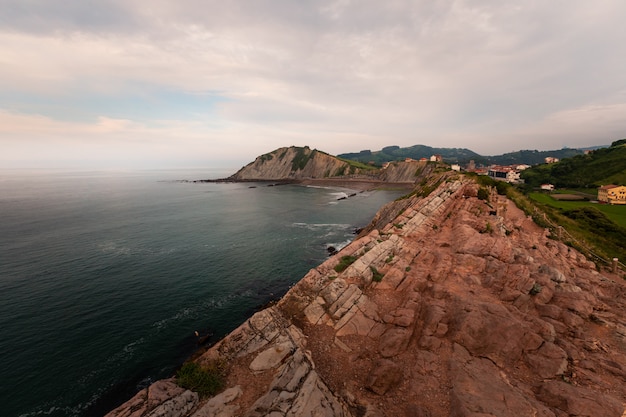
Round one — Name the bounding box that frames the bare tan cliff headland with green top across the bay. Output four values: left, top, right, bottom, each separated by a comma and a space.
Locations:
230, 146, 355, 181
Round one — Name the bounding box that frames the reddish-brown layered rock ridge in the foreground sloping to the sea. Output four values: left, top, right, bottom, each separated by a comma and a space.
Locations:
109, 176, 626, 417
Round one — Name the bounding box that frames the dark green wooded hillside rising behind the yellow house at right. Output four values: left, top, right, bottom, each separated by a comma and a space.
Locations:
522, 139, 626, 188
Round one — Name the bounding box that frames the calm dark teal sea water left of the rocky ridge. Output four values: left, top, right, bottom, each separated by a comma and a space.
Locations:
0, 170, 401, 417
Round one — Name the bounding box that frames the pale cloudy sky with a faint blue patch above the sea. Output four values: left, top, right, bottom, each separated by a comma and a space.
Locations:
0, 0, 626, 168
